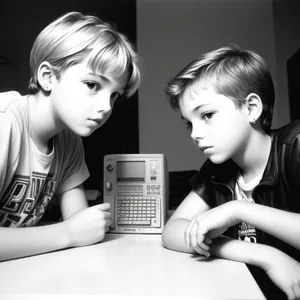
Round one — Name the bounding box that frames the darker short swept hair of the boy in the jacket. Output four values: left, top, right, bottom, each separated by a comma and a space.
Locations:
165, 45, 275, 132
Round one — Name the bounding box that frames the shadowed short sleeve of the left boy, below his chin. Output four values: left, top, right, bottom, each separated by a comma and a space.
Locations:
56, 132, 90, 194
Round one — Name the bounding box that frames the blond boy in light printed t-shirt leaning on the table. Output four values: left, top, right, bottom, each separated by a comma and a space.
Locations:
0, 12, 140, 260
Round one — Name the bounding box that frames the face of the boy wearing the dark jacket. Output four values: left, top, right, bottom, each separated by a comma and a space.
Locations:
179, 84, 251, 164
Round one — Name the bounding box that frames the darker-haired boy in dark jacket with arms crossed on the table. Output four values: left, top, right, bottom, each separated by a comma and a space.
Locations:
163, 45, 300, 299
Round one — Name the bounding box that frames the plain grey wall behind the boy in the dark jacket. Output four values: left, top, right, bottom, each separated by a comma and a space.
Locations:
137, 0, 289, 171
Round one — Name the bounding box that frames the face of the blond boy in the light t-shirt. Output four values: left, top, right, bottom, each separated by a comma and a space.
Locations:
51, 62, 128, 136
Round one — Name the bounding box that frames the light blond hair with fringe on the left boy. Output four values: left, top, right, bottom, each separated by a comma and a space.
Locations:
29, 12, 141, 97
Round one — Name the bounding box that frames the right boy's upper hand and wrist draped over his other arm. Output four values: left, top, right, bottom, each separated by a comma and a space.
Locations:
184, 201, 239, 257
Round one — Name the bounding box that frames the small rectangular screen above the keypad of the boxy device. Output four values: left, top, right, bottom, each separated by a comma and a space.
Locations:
117, 161, 146, 182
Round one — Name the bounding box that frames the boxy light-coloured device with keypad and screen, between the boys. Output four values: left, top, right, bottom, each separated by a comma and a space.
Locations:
103, 154, 169, 233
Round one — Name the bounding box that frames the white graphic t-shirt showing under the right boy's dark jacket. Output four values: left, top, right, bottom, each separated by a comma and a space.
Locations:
235, 173, 262, 243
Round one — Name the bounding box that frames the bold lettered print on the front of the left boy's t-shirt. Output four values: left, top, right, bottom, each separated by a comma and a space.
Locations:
0, 172, 56, 227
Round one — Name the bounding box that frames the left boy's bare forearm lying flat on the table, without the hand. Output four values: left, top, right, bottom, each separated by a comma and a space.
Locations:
0, 222, 71, 261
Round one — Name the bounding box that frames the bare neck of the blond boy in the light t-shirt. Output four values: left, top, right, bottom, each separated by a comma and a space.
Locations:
28, 92, 63, 154
